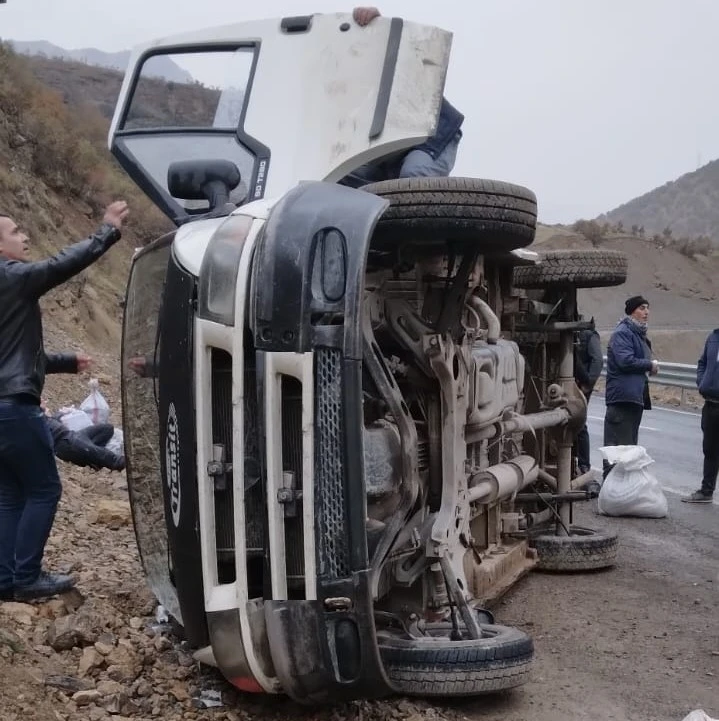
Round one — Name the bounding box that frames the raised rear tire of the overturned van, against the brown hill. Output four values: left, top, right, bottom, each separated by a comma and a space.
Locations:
514, 250, 628, 288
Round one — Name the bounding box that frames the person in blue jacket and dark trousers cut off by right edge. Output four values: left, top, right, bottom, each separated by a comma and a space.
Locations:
682, 328, 719, 503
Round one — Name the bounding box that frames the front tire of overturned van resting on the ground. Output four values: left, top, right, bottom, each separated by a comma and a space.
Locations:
379, 624, 534, 696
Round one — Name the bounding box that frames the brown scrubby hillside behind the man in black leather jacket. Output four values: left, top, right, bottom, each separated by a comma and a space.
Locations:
0, 46, 169, 360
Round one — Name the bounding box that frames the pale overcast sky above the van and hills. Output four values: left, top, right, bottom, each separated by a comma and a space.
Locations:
0, 0, 719, 223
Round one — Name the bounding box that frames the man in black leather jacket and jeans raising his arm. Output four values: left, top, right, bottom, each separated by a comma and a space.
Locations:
0, 201, 128, 600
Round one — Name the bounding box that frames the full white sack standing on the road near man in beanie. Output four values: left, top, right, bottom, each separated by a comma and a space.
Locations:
598, 446, 668, 518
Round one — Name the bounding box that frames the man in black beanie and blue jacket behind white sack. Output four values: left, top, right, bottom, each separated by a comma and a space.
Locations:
604, 295, 659, 478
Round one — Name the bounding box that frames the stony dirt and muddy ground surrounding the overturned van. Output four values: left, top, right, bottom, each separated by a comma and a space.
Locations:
0, 338, 719, 721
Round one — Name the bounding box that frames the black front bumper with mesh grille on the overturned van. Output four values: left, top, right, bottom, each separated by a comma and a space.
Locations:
250, 182, 393, 702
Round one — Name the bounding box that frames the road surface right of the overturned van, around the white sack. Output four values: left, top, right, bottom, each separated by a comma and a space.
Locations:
452, 396, 719, 721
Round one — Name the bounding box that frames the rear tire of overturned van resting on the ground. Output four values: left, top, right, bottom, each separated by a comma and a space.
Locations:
530, 526, 619, 571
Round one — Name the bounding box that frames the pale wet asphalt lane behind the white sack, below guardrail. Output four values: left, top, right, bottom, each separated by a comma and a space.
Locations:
587, 396, 718, 504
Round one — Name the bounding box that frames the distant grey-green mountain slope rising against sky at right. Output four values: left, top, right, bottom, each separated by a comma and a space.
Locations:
597, 160, 719, 243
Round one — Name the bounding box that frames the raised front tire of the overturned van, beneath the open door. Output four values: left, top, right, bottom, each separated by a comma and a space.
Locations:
361, 178, 537, 253
